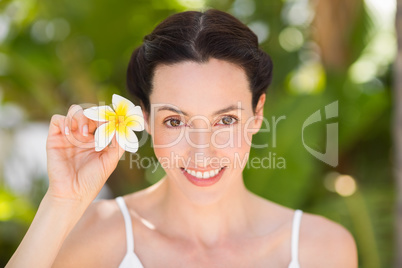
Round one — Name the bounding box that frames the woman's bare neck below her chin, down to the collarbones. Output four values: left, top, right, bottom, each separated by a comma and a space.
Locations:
154, 175, 253, 247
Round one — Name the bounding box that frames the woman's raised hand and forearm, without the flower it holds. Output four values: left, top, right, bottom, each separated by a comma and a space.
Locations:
6, 105, 124, 268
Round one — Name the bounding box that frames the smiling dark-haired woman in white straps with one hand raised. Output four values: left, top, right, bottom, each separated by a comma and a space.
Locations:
7, 9, 357, 268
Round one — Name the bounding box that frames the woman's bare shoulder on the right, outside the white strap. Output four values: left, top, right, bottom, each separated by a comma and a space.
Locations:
299, 212, 358, 268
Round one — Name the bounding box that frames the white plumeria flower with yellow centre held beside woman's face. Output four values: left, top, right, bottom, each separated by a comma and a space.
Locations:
84, 94, 144, 153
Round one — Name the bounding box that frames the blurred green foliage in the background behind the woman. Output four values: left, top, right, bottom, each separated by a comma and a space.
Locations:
0, 0, 395, 267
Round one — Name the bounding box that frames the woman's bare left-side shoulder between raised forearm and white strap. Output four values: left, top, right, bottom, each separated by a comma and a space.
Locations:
52, 199, 125, 267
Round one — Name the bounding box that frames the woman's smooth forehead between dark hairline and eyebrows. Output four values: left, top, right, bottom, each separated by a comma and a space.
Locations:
150, 58, 251, 112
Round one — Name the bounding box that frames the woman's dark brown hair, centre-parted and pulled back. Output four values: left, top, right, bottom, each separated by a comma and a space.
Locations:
127, 9, 273, 114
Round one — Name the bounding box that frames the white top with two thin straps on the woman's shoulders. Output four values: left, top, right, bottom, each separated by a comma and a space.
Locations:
116, 196, 303, 268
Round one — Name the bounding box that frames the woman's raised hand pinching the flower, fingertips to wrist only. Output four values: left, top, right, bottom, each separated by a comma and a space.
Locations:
46, 105, 124, 204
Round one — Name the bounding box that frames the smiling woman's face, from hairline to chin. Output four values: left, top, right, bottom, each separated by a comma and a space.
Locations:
147, 58, 265, 203
